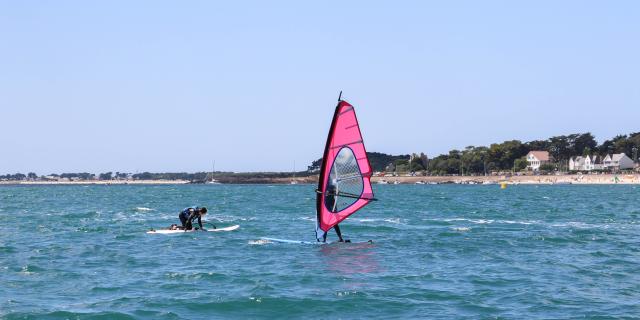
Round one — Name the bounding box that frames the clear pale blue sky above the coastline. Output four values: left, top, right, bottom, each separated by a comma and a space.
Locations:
0, 1, 640, 174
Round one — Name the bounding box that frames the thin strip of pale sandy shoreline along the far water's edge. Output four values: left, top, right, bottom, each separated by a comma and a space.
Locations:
0, 174, 640, 185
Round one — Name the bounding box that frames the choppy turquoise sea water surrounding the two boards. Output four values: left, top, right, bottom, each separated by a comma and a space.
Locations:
0, 185, 640, 319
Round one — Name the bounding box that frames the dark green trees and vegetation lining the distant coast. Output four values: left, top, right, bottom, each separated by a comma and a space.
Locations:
0, 132, 640, 183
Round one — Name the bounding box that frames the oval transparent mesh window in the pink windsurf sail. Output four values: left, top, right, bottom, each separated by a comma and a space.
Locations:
324, 147, 364, 212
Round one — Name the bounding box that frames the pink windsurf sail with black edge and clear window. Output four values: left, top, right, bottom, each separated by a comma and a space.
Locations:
316, 100, 375, 239
